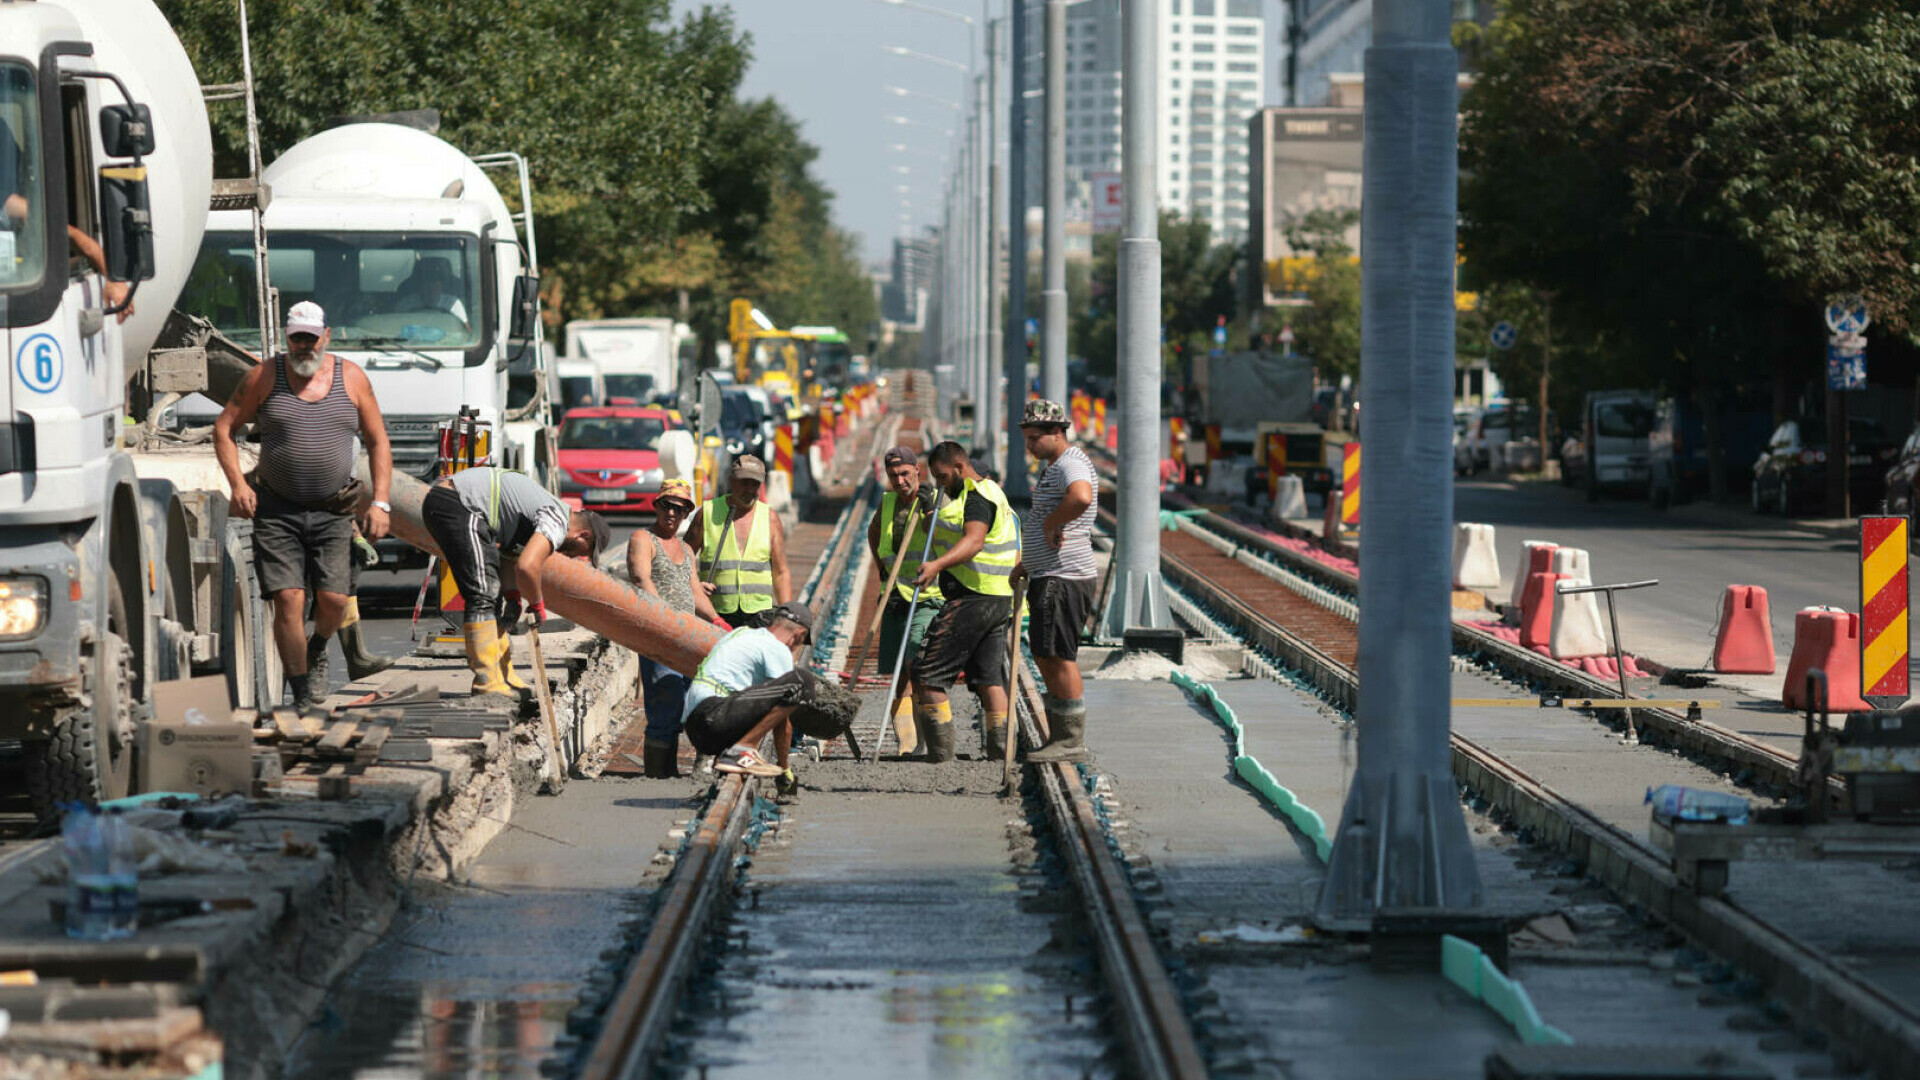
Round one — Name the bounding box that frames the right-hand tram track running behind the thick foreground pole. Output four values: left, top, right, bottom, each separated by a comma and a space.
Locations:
1108, 486, 1920, 1076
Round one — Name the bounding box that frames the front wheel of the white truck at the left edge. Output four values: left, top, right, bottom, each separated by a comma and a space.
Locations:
27, 575, 134, 807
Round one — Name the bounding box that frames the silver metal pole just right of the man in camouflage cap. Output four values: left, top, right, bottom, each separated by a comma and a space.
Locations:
1098, 0, 1173, 638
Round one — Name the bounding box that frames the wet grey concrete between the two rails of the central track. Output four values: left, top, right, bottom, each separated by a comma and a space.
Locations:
668, 734, 1114, 1080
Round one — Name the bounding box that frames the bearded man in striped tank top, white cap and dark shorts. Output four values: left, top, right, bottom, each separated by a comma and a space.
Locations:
213, 302, 394, 709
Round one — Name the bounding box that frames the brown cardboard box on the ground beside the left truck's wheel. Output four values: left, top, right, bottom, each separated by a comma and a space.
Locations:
140, 675, 253, 798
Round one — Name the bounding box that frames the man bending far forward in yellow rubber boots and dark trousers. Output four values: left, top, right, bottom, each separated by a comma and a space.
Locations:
420, 465, 612, 698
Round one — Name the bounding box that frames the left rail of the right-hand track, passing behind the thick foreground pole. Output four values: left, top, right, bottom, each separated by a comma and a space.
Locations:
1162, 507, 1920, 1078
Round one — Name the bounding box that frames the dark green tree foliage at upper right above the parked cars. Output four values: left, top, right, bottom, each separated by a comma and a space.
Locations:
1459, 0, 1920, 417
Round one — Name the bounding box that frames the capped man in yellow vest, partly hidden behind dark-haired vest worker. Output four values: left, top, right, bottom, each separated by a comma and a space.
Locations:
866, 446, 945, 753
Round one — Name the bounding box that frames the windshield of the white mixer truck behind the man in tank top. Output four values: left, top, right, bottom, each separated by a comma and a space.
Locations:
180, 231, 486, 363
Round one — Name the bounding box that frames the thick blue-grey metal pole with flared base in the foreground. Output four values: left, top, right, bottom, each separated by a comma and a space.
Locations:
1315, 0, 1484, 928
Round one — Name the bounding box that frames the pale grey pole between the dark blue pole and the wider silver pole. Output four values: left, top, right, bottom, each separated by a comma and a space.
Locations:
1041, 0, 1075, 404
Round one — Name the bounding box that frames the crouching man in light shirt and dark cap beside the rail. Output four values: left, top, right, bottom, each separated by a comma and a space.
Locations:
684, 601, 818, 780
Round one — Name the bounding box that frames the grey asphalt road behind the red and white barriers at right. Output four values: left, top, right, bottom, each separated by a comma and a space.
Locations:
1453, 480, 1896, 671
